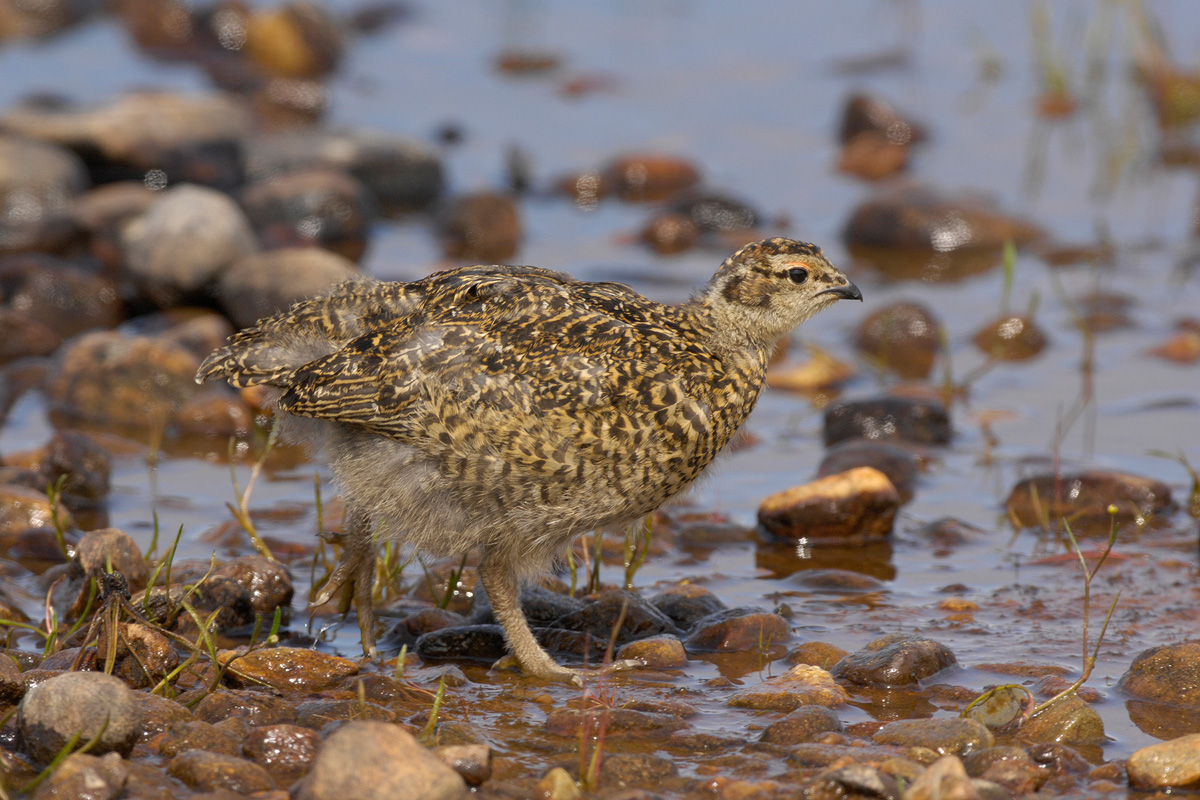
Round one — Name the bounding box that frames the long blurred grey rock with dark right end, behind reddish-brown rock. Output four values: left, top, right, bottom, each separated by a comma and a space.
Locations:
247, 130, 444, 213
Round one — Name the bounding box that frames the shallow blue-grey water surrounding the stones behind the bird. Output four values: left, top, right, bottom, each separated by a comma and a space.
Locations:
0, 0, 1200, 775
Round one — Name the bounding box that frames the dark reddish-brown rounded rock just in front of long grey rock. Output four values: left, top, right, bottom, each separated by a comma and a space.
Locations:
239, 168, 376, 261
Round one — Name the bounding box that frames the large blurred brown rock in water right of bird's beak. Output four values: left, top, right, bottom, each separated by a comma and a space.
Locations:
842, 181, 1042, 282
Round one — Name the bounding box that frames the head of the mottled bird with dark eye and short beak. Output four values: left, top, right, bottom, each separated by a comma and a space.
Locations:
698, 237, 863, 347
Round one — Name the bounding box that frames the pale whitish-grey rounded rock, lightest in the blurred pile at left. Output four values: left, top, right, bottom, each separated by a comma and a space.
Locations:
121, 184, 258, 308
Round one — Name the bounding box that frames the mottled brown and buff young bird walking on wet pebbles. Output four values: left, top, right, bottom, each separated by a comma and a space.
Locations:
196, 237, 863, 684
